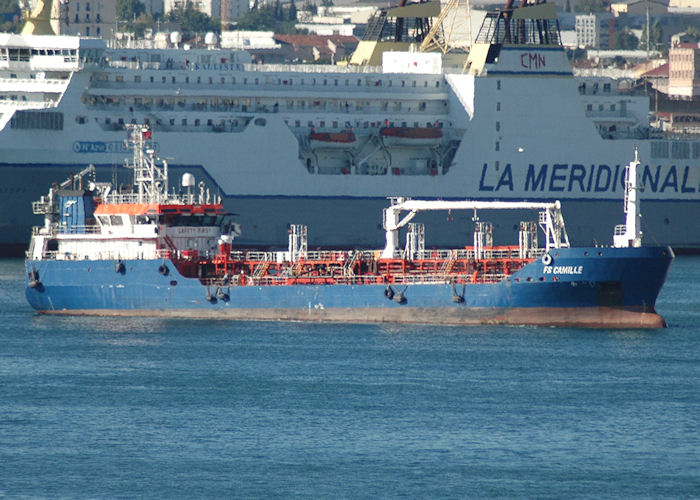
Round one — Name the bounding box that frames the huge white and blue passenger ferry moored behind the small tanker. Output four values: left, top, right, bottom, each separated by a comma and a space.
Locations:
0, 0, 700, 254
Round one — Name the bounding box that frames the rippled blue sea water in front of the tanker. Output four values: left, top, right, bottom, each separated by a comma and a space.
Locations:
0, 257, 700, 499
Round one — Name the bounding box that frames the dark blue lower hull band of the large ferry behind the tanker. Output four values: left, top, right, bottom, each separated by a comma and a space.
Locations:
0, 164, 700, 252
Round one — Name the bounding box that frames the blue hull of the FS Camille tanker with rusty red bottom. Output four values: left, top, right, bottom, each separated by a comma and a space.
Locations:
26, 247, 673, 327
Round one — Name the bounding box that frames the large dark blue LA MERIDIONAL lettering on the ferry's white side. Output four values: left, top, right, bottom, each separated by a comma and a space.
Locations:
479, 163, 700, 194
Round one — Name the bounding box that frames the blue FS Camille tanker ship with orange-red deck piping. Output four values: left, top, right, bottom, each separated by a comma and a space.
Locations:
26, 126, 673, 328
